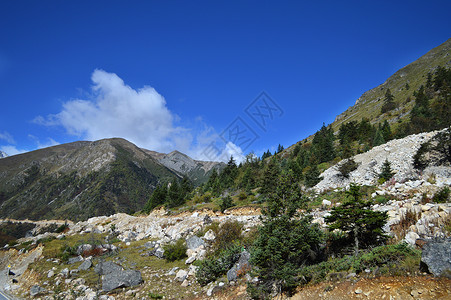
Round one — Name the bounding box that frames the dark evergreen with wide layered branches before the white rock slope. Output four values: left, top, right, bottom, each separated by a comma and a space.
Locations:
325, 184, 388, 255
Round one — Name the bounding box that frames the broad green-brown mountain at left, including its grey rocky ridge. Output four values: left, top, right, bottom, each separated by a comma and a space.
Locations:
0, 138, 218, 220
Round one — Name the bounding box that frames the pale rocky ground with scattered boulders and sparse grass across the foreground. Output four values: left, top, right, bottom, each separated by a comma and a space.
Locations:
0, 129, 451, 300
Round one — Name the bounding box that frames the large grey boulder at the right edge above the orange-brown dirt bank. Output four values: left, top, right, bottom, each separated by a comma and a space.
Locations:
421, 239, 451, 279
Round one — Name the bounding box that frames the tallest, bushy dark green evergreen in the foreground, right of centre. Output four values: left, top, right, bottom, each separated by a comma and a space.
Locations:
249, 172, 323, 298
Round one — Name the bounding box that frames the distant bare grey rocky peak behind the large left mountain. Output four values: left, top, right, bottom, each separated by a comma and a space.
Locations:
147, 149, 225, 185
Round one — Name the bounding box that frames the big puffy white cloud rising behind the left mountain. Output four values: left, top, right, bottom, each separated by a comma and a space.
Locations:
34, 70, 242, 160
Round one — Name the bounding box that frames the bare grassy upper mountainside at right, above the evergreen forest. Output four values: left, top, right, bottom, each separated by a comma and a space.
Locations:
332, 39, 451, 130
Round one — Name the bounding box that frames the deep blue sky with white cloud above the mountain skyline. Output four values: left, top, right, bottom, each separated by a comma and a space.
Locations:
0, 0, 451, 159
